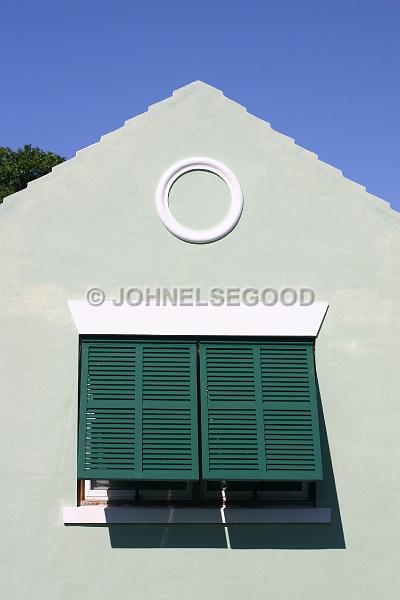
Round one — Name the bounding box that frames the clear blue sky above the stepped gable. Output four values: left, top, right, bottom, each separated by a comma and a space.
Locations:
0, 0, 400, 210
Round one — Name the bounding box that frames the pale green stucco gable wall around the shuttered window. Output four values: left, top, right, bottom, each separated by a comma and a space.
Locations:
0, 83, 400, 600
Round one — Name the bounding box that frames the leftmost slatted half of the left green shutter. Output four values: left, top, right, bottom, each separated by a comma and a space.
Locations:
78, 340, 140, 479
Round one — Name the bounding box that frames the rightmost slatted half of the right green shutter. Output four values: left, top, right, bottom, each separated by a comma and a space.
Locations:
260, 342, 322, 481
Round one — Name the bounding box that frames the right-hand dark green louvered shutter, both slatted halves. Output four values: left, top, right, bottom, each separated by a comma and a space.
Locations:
200, 341, 322, 480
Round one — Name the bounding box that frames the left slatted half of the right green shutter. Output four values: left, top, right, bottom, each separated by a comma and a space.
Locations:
200, 342, 265, 480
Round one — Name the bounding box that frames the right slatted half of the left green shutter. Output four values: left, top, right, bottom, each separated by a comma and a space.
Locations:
142, 342, 199, 479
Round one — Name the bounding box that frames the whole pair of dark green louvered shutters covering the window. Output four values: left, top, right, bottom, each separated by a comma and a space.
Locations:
78, 338, 322, 480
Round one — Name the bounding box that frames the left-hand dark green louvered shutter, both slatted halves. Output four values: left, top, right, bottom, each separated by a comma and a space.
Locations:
78, 338, 198, 480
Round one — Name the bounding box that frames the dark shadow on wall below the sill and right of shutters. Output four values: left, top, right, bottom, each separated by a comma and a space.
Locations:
108, 382, 346, 550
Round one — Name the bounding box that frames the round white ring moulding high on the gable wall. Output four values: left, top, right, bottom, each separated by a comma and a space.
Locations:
156, 157, 243, 244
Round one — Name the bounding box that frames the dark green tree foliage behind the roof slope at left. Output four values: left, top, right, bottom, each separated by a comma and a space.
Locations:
0, 144, 65, 203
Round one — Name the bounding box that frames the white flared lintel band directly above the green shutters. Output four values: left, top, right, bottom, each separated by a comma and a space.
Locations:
68, 300, 328, 337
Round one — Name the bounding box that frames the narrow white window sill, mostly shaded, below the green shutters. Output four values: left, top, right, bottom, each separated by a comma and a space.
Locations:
63, 506, 331, 525
